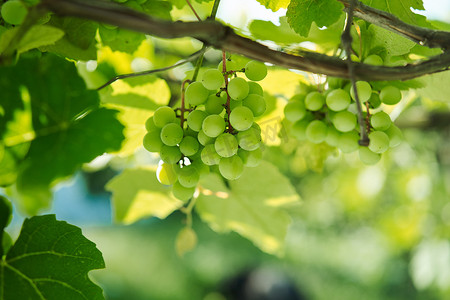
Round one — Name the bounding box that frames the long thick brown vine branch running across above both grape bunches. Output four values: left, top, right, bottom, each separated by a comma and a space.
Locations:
41, 0, 450, 81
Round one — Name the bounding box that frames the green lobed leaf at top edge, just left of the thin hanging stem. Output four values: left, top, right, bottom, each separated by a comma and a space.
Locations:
286, 0, 344, 37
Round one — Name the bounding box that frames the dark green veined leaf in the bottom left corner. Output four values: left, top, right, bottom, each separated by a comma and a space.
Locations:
0, 215, 105, 300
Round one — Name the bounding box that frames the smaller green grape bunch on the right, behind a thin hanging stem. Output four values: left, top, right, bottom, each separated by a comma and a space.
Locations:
284, 55, 402, 165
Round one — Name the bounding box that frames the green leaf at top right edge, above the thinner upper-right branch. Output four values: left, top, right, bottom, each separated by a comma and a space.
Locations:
361, 0, 431, 27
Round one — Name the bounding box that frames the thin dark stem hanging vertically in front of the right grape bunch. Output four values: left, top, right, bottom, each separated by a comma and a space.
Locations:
341, 0, 369, 146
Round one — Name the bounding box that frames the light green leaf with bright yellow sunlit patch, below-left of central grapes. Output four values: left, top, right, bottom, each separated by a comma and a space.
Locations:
106, 168, 183, 224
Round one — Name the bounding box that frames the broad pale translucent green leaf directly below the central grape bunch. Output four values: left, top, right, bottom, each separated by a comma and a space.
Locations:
195, 162, 299, 255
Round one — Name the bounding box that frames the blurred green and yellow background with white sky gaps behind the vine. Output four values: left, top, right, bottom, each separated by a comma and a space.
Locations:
3, 0, 450, 300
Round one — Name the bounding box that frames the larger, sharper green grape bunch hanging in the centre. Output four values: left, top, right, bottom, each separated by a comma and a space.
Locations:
143, 61, 267, 200
